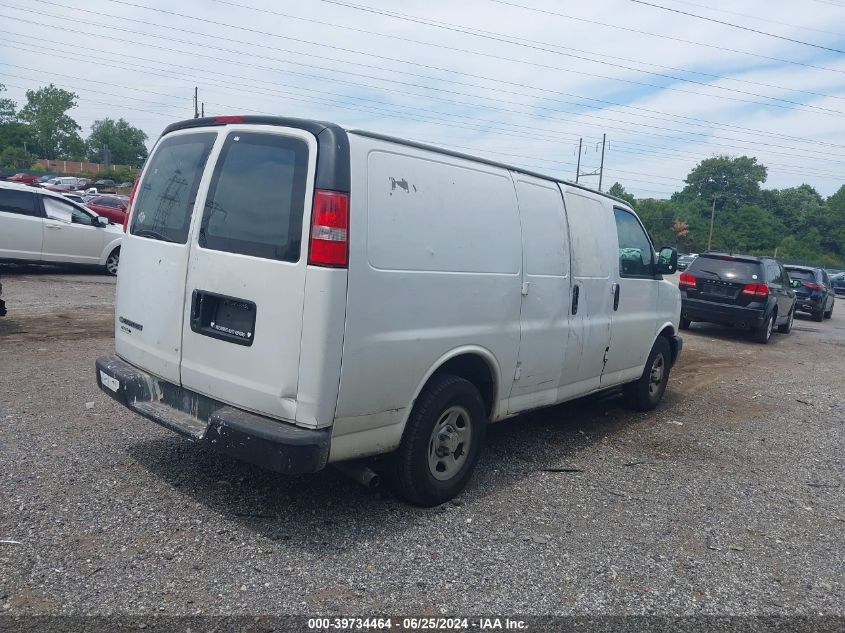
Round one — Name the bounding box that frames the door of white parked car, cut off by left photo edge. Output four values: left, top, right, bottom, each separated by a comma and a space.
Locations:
0, 188, 44, 261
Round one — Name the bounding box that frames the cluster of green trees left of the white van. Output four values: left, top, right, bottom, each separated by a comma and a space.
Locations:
0, 84, 147, 169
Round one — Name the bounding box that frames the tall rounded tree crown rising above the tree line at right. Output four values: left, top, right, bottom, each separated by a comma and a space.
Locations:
673, 156, 768, 212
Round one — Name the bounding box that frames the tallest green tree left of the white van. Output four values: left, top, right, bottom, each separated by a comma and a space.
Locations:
18, 84, 83, 159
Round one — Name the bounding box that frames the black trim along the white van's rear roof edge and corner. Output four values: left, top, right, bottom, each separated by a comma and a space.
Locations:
161, 115, 351, 193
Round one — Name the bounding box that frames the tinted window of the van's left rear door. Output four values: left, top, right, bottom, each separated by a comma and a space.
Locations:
130, 132, 217, 244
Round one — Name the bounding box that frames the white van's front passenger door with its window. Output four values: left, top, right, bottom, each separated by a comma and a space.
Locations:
602, 207, 658, 387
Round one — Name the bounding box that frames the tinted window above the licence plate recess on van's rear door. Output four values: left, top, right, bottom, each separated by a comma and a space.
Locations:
199, 132, 308, 262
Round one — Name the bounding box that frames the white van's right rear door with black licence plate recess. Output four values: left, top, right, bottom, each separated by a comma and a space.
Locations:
180, 125, 317, 421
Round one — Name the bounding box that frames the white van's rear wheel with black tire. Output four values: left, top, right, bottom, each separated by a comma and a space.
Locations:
393, 374, 487, 508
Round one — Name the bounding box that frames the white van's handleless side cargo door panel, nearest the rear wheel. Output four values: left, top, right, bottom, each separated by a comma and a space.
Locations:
508, 173, 570, 413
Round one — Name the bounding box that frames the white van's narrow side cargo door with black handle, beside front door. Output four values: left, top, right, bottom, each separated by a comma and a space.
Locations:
558, 187, 616, 400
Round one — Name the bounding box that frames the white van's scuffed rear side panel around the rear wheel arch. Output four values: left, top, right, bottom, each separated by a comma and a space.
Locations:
332, 134, 522, 461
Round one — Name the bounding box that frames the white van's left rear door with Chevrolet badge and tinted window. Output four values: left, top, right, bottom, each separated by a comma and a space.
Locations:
115, 130, 217, 384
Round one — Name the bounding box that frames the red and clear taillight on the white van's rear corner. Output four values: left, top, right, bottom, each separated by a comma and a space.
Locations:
308, 189, 349, 268
